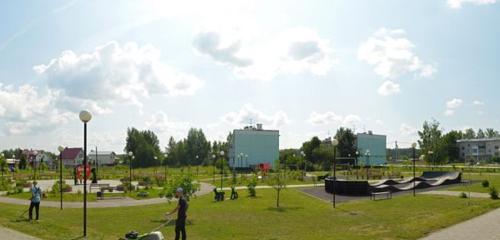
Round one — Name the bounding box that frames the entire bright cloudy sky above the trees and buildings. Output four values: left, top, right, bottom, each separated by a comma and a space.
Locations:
0, 0, 500, 152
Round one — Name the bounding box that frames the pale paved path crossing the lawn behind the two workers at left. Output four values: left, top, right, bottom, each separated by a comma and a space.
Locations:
0, 183, 214, 208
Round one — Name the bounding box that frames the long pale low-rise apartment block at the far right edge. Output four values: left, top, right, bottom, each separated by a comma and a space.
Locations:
457, 138, 500, 162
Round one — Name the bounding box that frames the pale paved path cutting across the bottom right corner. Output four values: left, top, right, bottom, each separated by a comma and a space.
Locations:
421, 209, 500, 240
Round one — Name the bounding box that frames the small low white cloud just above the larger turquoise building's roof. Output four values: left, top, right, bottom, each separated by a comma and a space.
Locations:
222, 104, 290, 129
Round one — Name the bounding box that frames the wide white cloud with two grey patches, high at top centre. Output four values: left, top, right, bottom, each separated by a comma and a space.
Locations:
193, 27, 336, 80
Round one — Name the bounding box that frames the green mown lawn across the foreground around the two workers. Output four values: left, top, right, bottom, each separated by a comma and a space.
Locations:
0, 189, 500, 240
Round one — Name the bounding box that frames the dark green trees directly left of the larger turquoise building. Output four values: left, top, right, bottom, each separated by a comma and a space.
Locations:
124, 128, 232, 167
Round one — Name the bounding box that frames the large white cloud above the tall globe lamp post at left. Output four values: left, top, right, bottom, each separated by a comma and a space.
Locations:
33, 42, 203, 112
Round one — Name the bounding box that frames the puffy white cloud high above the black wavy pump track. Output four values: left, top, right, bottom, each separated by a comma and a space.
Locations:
358, 28, 437, 79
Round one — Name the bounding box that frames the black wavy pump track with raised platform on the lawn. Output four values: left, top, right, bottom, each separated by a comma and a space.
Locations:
325, 172, 462, 196
